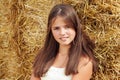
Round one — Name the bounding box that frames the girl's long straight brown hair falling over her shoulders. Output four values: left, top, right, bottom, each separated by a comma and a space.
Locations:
33, 4, 96, 77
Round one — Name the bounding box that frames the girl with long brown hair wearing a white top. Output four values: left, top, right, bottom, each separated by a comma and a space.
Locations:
31, 4, 96, 80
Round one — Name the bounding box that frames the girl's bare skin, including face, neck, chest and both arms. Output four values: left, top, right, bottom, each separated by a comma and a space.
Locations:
31, 16, 93, 80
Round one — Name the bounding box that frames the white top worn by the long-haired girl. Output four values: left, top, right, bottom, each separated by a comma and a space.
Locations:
41, 66, 72, 80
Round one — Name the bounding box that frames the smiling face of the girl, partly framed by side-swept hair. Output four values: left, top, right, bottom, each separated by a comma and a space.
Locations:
51, 16, 76, 45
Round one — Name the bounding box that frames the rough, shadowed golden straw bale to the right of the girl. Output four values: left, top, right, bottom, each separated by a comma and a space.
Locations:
64, 0, 120, 80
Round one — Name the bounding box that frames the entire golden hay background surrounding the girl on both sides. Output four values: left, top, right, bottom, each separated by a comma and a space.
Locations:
0, 0, 120, 80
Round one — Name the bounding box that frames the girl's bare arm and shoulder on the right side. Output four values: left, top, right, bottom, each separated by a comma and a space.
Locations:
72, 59, 93, 80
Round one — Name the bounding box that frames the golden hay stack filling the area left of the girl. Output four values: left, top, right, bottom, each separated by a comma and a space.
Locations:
0, 0, 62, 80
